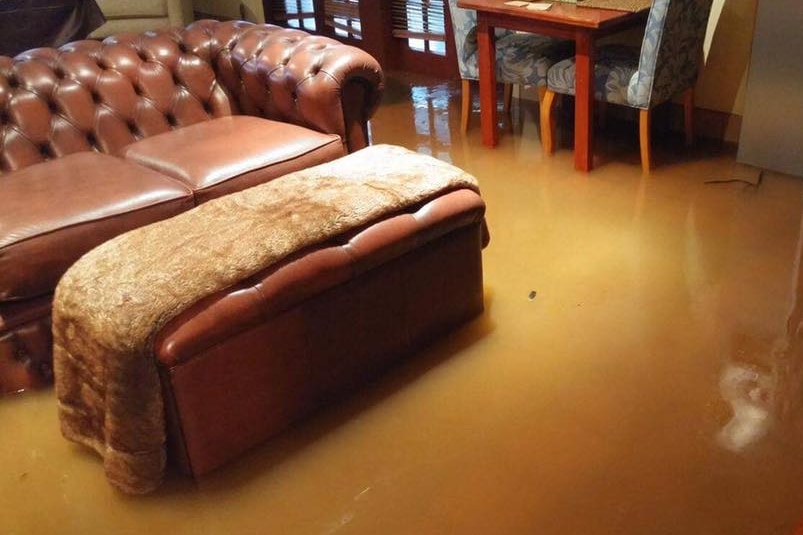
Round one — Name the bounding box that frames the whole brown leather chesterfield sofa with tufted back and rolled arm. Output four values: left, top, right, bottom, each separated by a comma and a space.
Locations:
0, 21, 383, 393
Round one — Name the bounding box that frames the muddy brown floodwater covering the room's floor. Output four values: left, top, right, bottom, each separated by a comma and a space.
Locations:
0, 76, 803, 535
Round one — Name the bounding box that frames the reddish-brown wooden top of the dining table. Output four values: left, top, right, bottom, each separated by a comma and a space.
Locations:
457, 0, 646, 29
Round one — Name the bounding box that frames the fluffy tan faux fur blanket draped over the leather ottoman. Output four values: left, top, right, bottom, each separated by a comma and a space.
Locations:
53, 145, 484, 493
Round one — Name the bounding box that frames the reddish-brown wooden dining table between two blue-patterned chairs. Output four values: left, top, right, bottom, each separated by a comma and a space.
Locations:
457, 0, 649, 171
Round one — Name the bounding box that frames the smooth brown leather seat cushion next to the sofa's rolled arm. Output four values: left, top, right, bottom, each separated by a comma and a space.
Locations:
121, 115, 346, 204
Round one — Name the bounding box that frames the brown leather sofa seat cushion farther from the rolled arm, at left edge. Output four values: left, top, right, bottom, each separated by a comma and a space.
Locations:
0, 152, 194, 302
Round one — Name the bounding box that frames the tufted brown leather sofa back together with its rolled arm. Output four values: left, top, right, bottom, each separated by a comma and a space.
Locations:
0, 21, 382, 173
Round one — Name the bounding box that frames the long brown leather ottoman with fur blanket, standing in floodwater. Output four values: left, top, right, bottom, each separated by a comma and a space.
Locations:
53, 146, 488, 493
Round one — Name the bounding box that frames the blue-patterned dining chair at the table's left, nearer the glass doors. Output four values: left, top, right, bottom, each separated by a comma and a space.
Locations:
449, 0, 573, 132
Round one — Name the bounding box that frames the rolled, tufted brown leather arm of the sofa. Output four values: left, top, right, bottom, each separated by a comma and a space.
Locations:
181, 20, 384, 152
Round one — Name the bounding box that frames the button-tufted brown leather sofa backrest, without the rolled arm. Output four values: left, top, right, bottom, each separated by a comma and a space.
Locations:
0, 33, 232, 172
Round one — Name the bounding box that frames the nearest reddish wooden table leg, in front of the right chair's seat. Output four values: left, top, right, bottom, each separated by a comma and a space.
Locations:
574, 31, 594, 172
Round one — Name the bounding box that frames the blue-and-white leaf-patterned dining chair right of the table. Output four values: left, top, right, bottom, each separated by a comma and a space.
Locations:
541, 0, 712, 172
